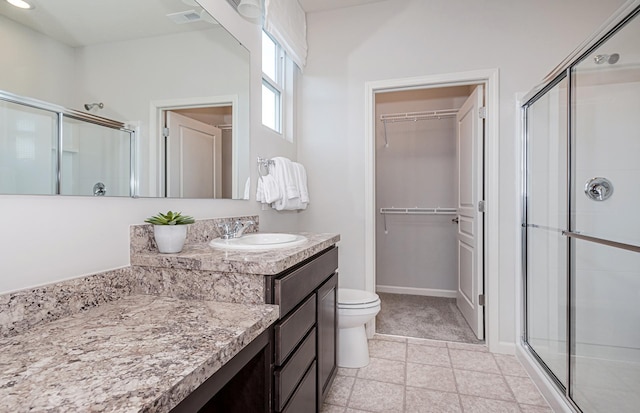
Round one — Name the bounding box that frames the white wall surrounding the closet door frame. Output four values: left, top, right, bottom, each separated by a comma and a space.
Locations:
298, 0, 623, 343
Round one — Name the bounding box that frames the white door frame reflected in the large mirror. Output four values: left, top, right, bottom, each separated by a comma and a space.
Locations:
149, 95, 242, 199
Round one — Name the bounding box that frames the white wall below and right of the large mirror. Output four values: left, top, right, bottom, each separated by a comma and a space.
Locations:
0, 0, 304, 293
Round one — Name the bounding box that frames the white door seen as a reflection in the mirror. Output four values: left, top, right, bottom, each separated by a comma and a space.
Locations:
166, 111, 222, 198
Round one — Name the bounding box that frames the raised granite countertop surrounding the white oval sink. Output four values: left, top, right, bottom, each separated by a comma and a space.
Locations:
131, 232, 340, 275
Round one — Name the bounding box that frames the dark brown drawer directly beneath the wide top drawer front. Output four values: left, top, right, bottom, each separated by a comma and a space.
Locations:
275, 294, 316, 366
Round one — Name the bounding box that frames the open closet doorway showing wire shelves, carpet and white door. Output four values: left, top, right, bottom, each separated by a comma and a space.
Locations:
370, 69, 500, 343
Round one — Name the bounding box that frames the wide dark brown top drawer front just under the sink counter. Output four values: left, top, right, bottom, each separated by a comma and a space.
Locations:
274, 247, 338, 314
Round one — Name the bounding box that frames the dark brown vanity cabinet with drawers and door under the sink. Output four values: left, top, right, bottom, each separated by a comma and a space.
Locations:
265, 246, 338, 413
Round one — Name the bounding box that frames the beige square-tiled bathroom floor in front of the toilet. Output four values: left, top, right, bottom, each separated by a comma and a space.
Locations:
322, 335, 552, 413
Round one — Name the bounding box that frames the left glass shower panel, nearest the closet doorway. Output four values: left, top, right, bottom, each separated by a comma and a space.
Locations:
525, 77, 568, 388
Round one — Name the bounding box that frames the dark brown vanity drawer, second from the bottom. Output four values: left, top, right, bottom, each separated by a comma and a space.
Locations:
275, 328, 316, 411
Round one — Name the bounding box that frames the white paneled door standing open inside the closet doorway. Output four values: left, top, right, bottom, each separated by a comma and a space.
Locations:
456, 86, 484, 339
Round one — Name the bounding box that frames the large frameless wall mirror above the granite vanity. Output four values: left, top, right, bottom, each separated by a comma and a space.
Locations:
0, 0, 250, 199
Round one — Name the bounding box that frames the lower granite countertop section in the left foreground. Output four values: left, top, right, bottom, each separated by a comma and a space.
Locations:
0, 295, 278, 412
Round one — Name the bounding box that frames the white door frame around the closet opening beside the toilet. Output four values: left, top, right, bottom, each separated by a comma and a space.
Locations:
364, 68, 500, 353
